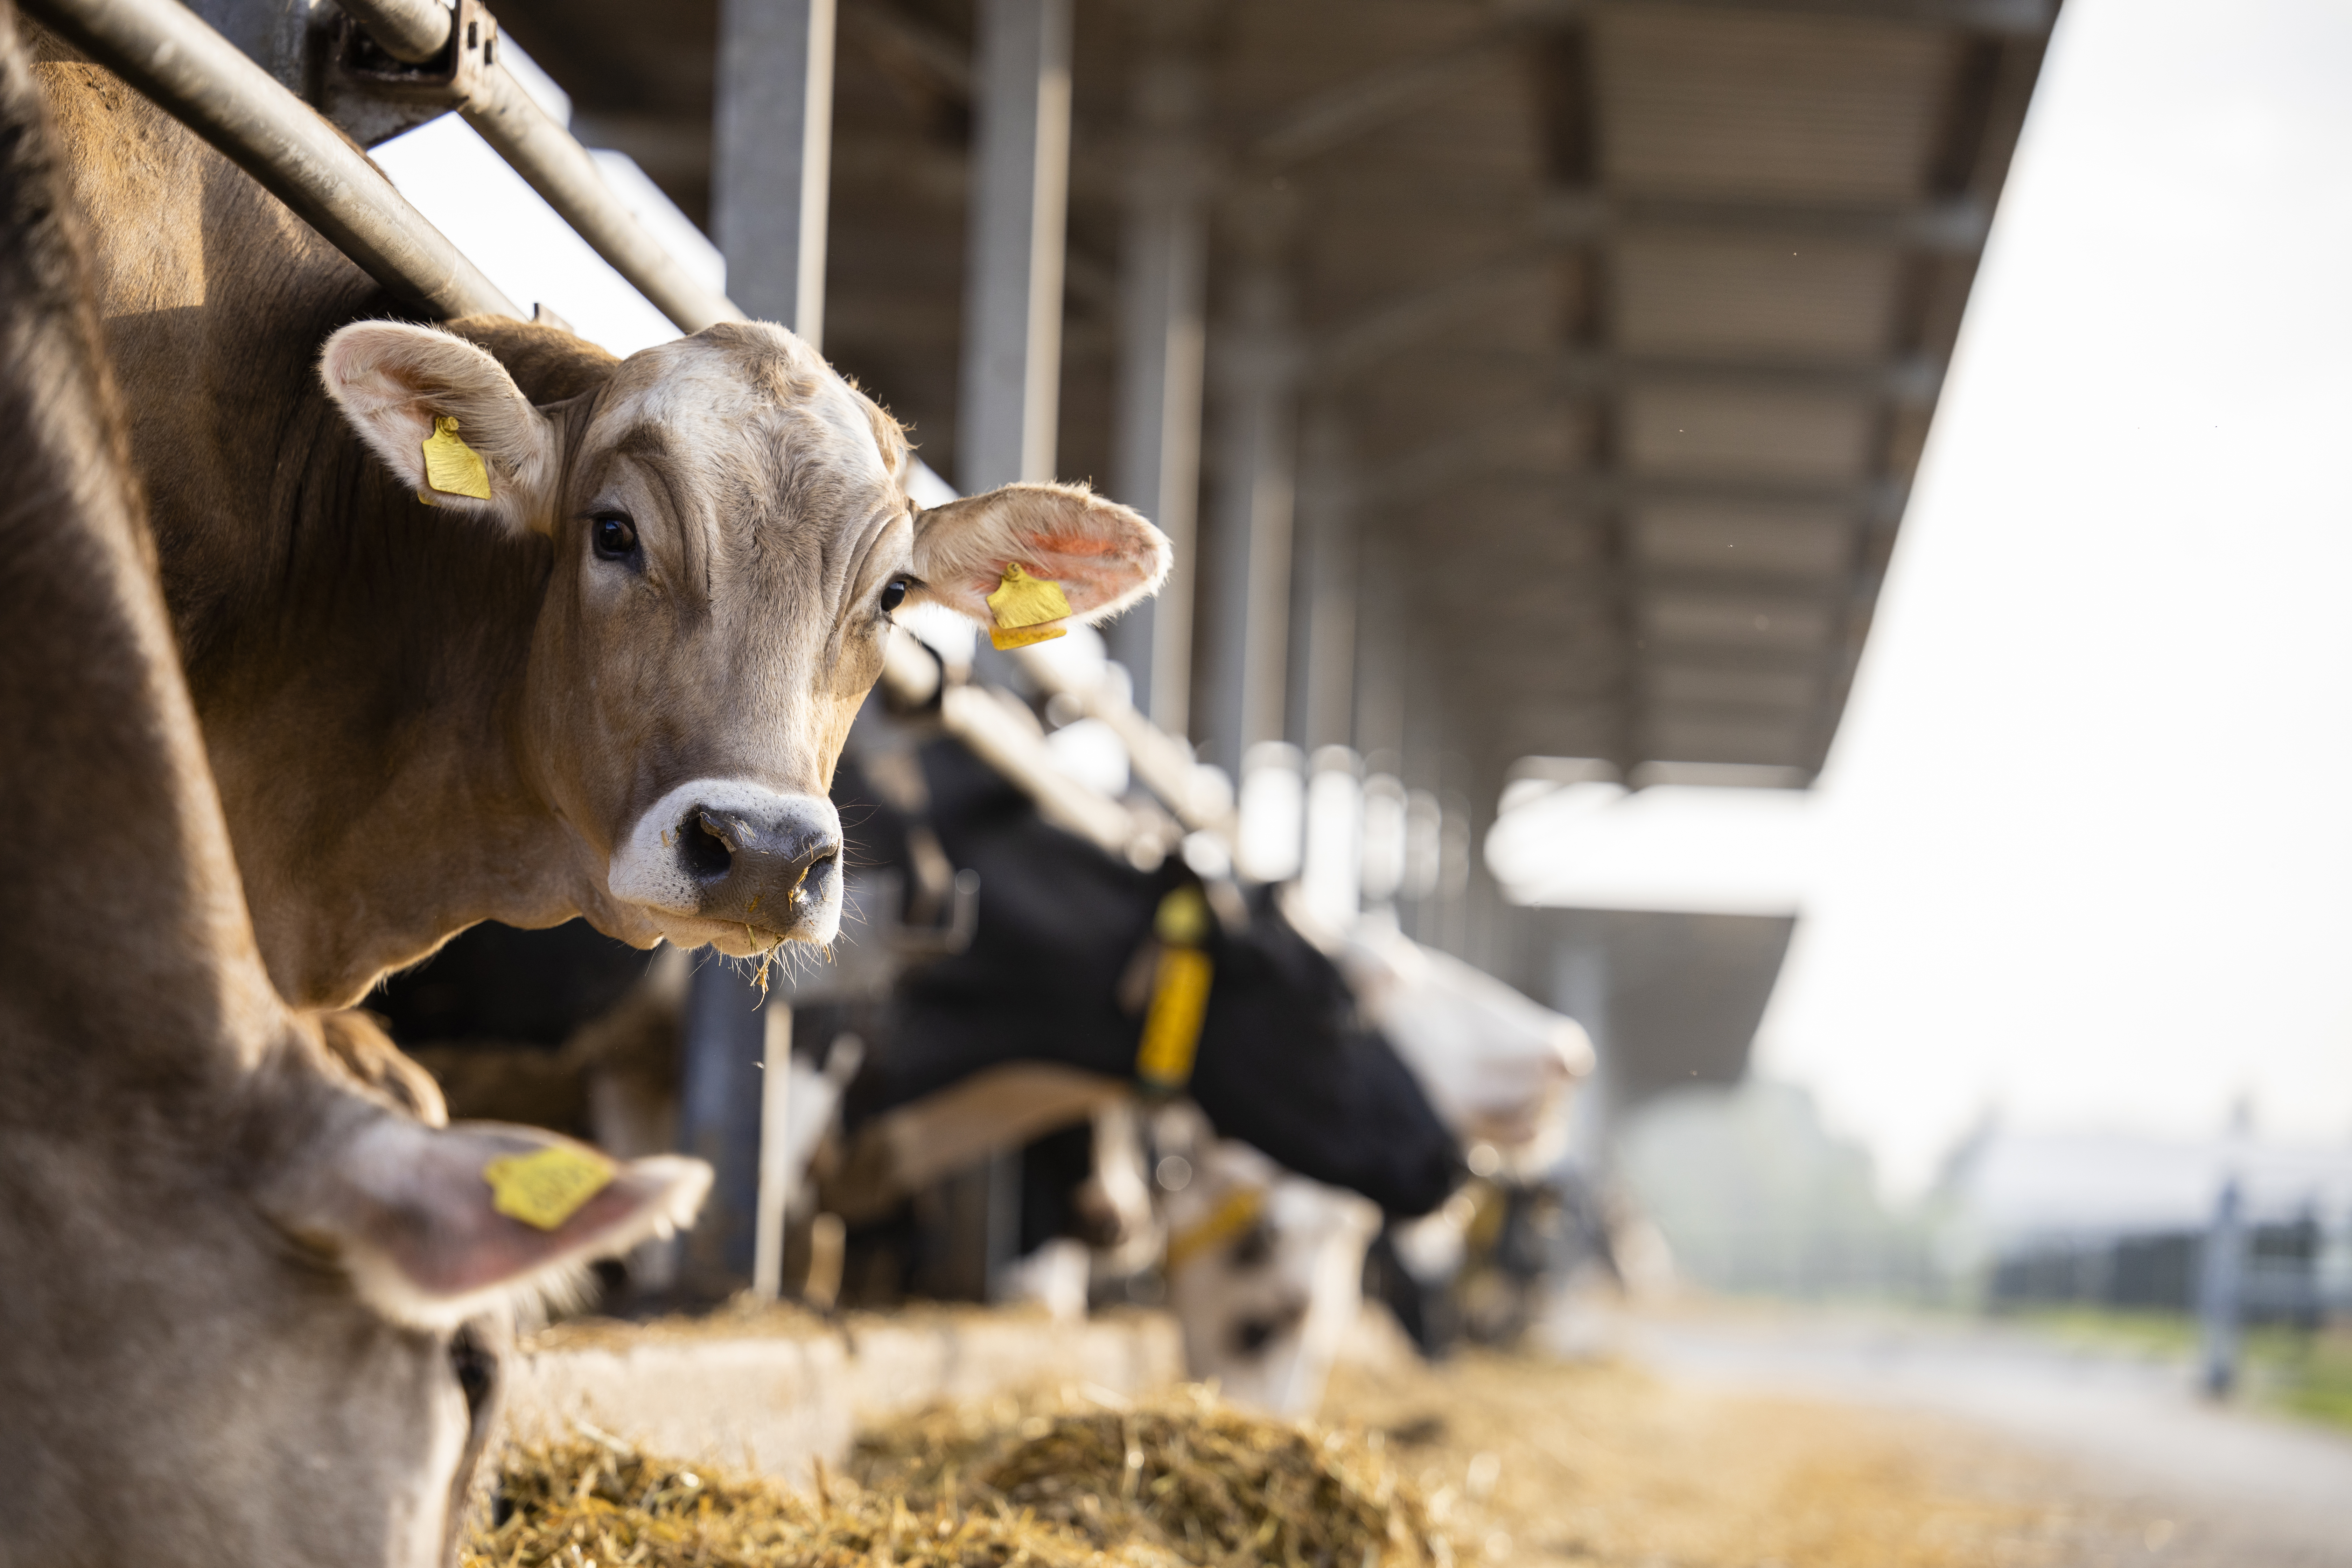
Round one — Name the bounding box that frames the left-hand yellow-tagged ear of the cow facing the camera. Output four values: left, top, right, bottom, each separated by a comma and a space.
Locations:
317, 322, 560, 529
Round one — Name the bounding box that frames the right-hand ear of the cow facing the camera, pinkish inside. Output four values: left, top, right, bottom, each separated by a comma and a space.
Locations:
910, 484, 1169, 625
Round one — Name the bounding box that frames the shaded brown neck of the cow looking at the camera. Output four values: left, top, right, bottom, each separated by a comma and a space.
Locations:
190, 423, 576, 1006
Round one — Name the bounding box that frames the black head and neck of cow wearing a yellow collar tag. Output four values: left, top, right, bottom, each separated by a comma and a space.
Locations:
835, 738, 1461, 1216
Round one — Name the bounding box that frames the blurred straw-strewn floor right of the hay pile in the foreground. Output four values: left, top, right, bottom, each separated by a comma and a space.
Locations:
1322, 1326, 2314, 1568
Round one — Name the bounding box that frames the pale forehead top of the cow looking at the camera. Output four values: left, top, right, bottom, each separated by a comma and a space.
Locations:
588, 322, 894, 503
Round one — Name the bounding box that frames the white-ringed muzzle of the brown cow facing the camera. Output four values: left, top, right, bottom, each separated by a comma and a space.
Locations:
604, 778, 842, 959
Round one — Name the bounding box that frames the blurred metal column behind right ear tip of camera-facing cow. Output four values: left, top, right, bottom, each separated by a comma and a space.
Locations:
1108, 52, 1209, 736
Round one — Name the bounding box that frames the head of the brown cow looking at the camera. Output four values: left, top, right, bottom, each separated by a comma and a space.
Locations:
320, 322, 1169, 957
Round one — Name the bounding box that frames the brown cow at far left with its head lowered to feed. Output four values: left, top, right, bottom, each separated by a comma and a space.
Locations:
0, 18, 710, 1568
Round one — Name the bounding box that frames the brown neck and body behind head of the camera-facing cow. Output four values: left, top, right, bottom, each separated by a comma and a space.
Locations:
42, 63, 611, 1006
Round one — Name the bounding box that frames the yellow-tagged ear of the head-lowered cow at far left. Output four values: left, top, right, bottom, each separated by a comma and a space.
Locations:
264, 1112, 710, 1328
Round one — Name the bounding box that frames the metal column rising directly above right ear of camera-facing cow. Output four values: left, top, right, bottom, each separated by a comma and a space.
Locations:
955, 0, 1070, 496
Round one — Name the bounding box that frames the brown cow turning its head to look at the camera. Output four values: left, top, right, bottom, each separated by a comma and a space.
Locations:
42, 45, 1167, 1006
